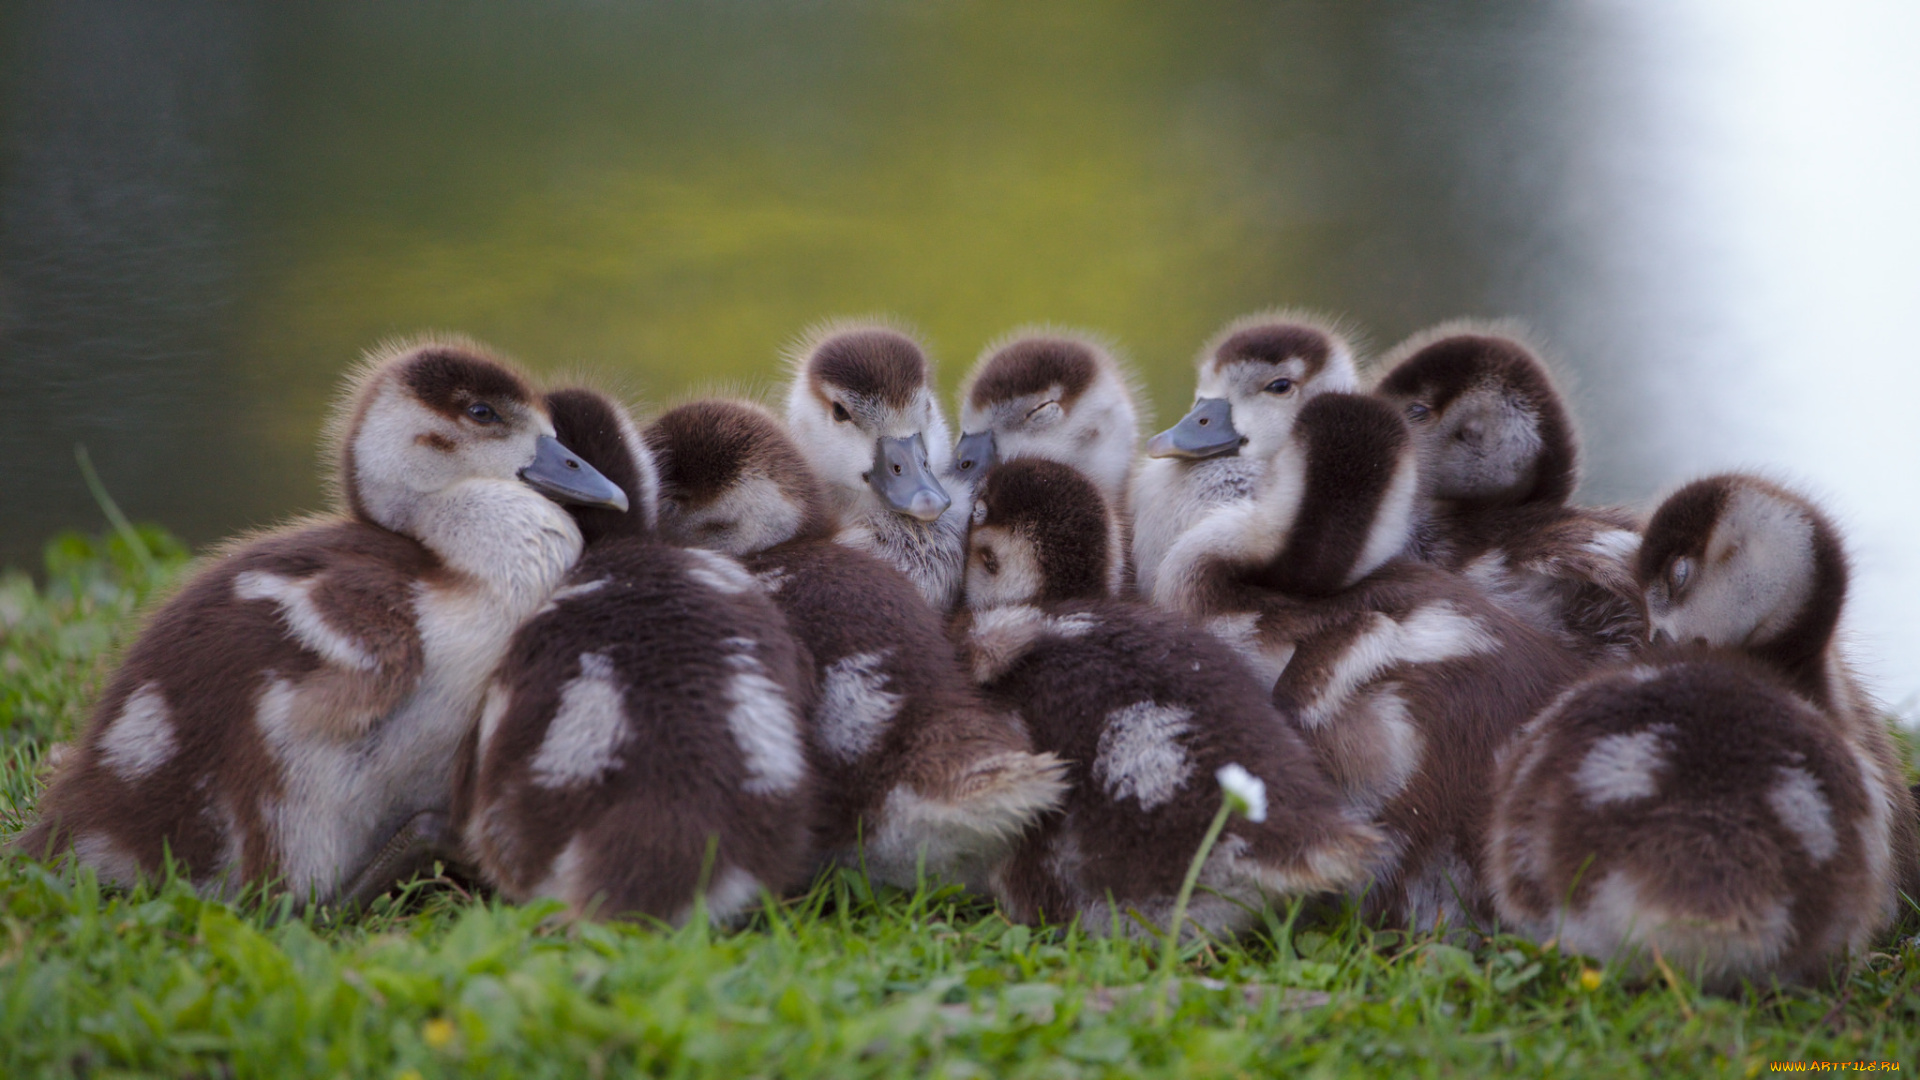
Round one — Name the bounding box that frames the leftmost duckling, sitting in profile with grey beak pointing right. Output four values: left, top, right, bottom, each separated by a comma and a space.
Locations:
15, 340, 626, 901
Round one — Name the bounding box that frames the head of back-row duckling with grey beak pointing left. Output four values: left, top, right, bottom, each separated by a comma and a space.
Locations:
1146, 313, 1359, 459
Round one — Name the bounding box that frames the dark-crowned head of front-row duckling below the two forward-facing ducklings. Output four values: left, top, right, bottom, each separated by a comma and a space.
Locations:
966, 457, 1116, 611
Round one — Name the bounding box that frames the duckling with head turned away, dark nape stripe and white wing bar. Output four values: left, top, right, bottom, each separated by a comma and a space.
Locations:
1154, 394, 1578, 930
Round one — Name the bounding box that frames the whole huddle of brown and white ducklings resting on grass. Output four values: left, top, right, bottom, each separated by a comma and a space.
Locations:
15, 313, 1920, 986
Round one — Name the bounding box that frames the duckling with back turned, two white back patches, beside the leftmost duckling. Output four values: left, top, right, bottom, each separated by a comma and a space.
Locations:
457, 390, 816, 922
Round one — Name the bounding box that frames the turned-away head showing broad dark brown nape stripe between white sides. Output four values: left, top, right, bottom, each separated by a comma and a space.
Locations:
1250, 394, 1419, 596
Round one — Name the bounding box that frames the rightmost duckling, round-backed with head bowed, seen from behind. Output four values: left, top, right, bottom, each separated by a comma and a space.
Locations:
1490, 475, 1916, 990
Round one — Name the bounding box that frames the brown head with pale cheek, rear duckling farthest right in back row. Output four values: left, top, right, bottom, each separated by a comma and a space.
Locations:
1375, 323, 1578, 505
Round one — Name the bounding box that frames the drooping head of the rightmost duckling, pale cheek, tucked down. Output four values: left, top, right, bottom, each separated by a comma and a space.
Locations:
1636, 473, 1847, 705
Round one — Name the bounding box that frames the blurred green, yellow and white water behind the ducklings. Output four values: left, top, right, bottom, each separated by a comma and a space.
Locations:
0, 0, 1920, 715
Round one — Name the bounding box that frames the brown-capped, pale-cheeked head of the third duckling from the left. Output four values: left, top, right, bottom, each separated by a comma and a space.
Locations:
647, 400, 829, 557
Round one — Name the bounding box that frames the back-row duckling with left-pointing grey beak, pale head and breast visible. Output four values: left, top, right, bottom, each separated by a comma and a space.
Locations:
1129, 311, 1359, 596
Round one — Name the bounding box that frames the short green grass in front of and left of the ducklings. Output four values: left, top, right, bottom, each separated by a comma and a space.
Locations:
0, 530, 1920, 1078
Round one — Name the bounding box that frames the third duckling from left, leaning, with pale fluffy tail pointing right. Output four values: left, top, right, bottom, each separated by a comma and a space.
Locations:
647, 402, 1062, 888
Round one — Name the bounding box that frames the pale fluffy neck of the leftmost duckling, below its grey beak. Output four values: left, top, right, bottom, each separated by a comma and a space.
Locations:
399, 479, 582, 613
